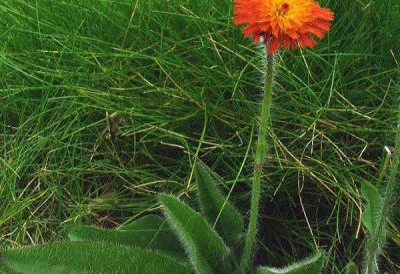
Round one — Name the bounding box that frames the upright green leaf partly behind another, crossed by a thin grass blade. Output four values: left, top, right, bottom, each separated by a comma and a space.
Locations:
195, 162, 243, 247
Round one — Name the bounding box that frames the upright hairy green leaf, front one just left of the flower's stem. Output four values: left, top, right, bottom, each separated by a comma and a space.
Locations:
160, 194, 233, 274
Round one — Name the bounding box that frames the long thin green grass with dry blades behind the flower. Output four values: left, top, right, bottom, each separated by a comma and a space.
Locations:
0, 0, 400, 273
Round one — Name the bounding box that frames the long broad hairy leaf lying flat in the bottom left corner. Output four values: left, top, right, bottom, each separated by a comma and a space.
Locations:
0, 242, 193, 274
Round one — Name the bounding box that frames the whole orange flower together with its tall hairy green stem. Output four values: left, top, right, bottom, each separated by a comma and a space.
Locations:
234, 0, 334, 273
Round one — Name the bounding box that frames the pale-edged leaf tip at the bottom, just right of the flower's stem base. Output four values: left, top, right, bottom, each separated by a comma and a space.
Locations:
256, 252, 324, 274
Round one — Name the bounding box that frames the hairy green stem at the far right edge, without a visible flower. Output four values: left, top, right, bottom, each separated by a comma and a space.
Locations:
366, 105, 400, 274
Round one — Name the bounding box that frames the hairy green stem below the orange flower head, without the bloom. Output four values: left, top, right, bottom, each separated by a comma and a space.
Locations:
240, 51, 274, 273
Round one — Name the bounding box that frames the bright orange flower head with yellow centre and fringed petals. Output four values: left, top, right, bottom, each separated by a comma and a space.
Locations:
234, 0, 334, 53
